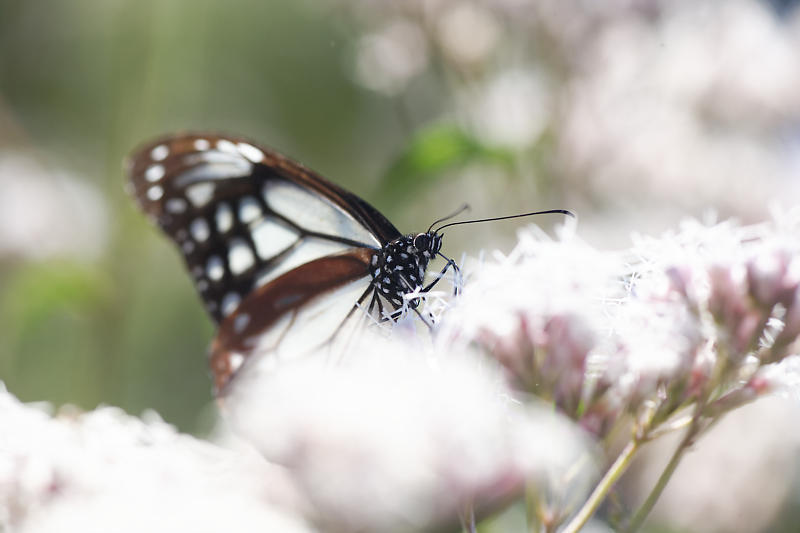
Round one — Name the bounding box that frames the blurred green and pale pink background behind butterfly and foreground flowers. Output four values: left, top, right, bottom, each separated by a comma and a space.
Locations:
0, 0, 800, 531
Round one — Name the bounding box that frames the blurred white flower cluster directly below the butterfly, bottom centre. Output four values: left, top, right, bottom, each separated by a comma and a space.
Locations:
224, 336, 591, 531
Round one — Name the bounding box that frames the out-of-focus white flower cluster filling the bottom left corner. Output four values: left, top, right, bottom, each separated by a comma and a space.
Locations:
0, 386, 313, 533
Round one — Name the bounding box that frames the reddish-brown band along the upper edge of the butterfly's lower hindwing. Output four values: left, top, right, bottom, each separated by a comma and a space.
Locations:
210, 248, 373, 396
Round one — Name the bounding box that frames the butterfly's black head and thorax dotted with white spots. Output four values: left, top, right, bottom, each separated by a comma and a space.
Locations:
370, 232, 442, 308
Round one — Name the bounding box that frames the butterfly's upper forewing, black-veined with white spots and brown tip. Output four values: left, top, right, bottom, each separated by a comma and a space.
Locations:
128, 134, 401, 322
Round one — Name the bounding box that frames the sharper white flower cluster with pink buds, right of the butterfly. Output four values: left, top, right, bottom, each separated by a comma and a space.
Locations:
441, 215, 800, 437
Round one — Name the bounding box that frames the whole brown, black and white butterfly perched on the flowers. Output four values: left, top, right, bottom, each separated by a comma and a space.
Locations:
126, 133, 458, 396
